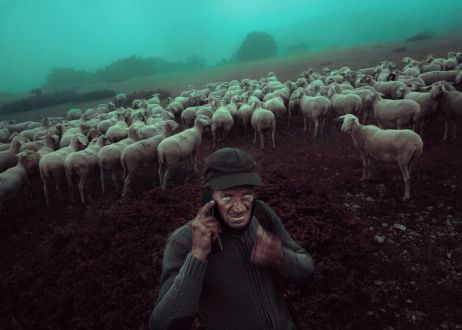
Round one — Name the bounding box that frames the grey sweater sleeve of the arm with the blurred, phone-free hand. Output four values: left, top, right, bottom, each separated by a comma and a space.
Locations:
260, 201, 314, 284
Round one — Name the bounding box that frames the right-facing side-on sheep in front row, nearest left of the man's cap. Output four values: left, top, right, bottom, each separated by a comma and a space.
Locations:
157, 115, 211, 191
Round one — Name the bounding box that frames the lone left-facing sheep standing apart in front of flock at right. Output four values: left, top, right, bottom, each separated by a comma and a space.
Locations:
338, 114, 423, 201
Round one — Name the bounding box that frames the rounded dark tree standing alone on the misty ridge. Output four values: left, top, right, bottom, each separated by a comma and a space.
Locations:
233, 31, 277, 62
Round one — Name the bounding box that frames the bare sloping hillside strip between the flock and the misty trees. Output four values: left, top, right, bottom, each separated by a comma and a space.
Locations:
0, 32, 462, 120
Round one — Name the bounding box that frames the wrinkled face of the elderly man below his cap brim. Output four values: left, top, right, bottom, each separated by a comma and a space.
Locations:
212, 186, 255, 229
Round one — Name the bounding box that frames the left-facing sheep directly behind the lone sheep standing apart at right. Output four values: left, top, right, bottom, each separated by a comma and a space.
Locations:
368, 92, 420, 129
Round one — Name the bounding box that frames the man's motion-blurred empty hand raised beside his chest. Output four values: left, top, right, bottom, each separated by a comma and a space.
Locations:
251, 226, 282, 266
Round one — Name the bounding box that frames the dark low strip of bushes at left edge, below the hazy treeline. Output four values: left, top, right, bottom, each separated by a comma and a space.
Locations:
0, 89, 116, 114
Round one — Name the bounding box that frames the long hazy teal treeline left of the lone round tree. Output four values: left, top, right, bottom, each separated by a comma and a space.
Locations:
42, 55, 206, 91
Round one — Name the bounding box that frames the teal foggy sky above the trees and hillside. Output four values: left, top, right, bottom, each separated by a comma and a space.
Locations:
0, 0, 462, 92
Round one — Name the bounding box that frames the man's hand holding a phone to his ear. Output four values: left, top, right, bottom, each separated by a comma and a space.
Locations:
191, 200, 221, 260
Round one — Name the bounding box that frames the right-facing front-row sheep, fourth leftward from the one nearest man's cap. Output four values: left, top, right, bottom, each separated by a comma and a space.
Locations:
64, 135, 107, 203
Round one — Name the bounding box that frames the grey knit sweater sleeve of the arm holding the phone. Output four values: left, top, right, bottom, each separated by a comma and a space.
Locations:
149, 228, 207, 330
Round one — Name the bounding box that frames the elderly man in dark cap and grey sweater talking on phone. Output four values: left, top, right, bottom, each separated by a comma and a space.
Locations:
150, 148, 314, 330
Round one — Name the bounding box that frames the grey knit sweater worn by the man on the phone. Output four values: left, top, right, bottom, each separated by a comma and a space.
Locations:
150, 202, 314, 330
